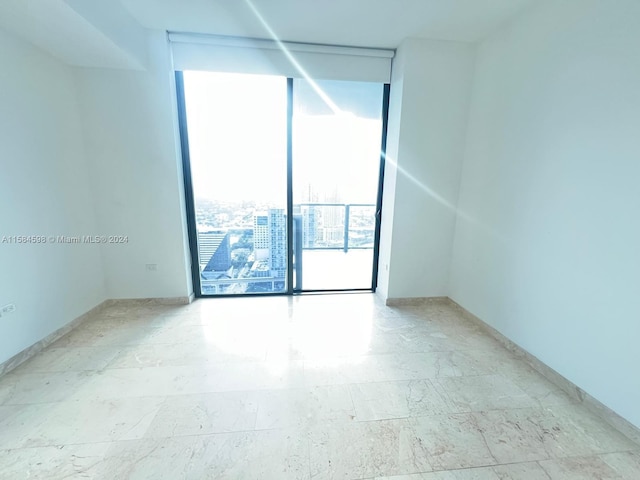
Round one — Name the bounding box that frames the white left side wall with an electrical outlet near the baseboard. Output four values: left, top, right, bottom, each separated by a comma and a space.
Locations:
0, 30, 105, 363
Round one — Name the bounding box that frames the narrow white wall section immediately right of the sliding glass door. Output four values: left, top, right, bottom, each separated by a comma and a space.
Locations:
378, 39, 474, 298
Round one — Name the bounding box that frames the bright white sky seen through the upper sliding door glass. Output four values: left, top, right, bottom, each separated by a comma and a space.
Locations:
184, 71, 382, 207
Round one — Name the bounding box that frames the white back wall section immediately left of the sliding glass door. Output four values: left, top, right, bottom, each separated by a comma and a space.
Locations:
77, 32, 191, 298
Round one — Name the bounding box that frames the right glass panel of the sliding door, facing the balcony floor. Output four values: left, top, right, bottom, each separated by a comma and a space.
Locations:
292, 79, 384, 291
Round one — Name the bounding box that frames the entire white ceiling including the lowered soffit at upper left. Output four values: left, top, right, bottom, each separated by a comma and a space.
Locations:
0, 0, 538, 68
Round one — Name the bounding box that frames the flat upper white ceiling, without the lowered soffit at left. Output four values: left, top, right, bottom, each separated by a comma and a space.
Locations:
121, 0, 534, 48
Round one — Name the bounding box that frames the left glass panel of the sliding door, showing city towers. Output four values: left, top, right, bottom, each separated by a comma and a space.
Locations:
183, 71, 288, 295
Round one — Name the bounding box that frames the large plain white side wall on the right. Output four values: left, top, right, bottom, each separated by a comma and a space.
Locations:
450, 0, 640, 426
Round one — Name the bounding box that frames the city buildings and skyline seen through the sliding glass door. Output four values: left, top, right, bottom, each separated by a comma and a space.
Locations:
198, 198, 375, 293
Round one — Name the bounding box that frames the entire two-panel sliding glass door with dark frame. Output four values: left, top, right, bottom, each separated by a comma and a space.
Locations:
176, 71, 388, 296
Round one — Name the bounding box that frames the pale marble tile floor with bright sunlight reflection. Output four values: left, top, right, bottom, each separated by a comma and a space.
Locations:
0, 294, 640, 480
